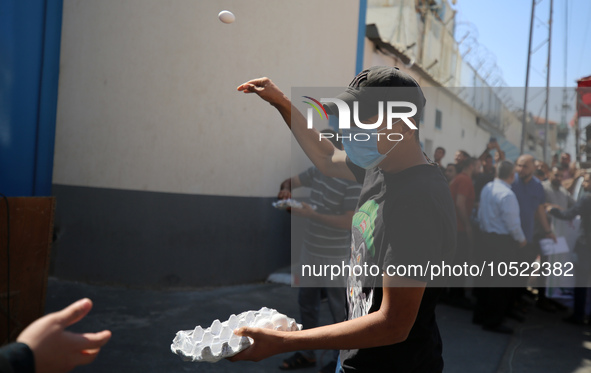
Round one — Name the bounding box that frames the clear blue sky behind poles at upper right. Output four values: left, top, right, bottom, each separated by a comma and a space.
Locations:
455, 0, 591, 87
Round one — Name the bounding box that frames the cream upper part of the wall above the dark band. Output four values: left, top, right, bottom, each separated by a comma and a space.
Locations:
53, 0, 359, 196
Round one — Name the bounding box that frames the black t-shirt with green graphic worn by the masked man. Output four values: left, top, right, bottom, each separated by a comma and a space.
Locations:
341, 159, 456, 373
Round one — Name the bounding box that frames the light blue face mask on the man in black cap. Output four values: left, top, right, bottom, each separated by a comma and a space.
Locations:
342, 121, 400, 170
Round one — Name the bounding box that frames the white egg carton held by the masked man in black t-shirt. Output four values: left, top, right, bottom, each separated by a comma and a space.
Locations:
170, 307, 302, 363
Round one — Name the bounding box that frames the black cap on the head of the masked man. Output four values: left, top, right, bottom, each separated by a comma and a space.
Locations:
324, 66, 426, 122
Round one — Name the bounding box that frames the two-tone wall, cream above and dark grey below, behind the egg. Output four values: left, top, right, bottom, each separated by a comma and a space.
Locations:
53, 0, 359, 286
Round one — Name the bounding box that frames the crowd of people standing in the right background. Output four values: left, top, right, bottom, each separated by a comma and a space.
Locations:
434, 138, 591, 333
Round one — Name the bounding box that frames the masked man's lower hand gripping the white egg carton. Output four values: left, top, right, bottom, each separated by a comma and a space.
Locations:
228, 326, 287, 362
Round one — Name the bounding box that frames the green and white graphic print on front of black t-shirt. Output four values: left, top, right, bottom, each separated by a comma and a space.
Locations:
347, 200, 379, 320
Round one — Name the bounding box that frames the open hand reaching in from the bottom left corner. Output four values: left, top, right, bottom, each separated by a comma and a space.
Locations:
17, 298, 111, 373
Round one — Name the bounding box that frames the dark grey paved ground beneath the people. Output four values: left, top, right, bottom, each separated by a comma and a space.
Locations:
46, 279, 591, 373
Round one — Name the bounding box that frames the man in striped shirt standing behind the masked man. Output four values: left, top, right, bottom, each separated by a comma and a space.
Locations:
278, 130, 361, 372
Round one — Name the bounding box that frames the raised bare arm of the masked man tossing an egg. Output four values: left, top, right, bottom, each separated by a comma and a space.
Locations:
238, 78, 355, 180
